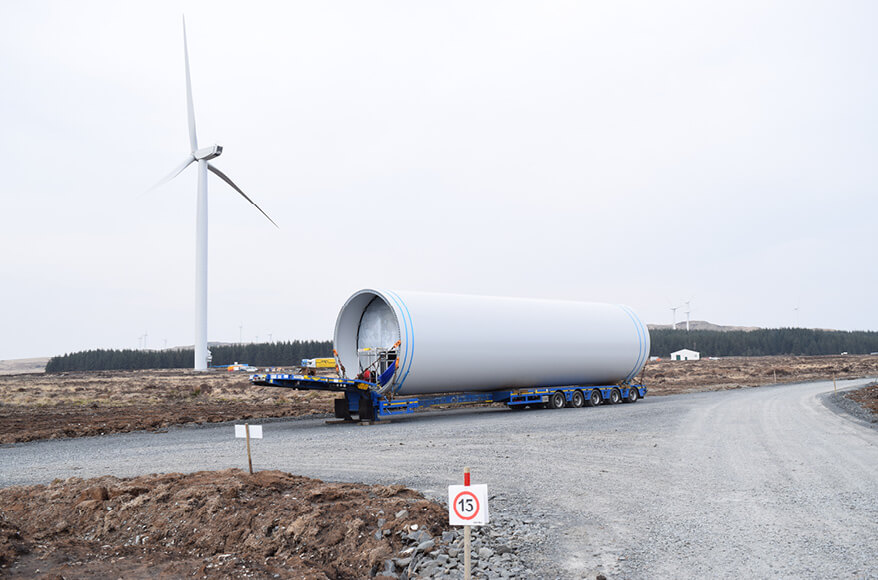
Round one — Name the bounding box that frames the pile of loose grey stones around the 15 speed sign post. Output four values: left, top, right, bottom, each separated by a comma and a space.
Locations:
377, 496, 546, 580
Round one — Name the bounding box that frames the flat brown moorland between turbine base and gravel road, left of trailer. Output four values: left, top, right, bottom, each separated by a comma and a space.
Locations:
0, 370, 335, 443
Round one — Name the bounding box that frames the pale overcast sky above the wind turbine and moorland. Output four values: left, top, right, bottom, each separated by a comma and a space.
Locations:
0, 0, 878, 359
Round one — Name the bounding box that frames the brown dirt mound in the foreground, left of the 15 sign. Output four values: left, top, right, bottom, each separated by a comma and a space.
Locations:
0, 470, 447, 579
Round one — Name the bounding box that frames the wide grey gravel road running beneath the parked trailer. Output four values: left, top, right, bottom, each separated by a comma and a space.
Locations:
0, 380, 878, 578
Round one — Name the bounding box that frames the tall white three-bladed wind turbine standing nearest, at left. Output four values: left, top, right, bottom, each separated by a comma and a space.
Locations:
151, 17, 278, 371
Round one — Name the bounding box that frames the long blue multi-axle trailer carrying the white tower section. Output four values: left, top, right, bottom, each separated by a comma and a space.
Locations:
250, 373, 646, 421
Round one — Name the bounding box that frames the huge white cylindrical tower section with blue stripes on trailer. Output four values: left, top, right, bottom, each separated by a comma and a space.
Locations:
335, 290, 649, 395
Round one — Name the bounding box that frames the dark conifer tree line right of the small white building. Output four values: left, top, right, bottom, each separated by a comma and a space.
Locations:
649, 328, 878, 358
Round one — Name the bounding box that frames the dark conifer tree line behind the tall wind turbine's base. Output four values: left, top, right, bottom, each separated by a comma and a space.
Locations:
46, 340, 332, 373
